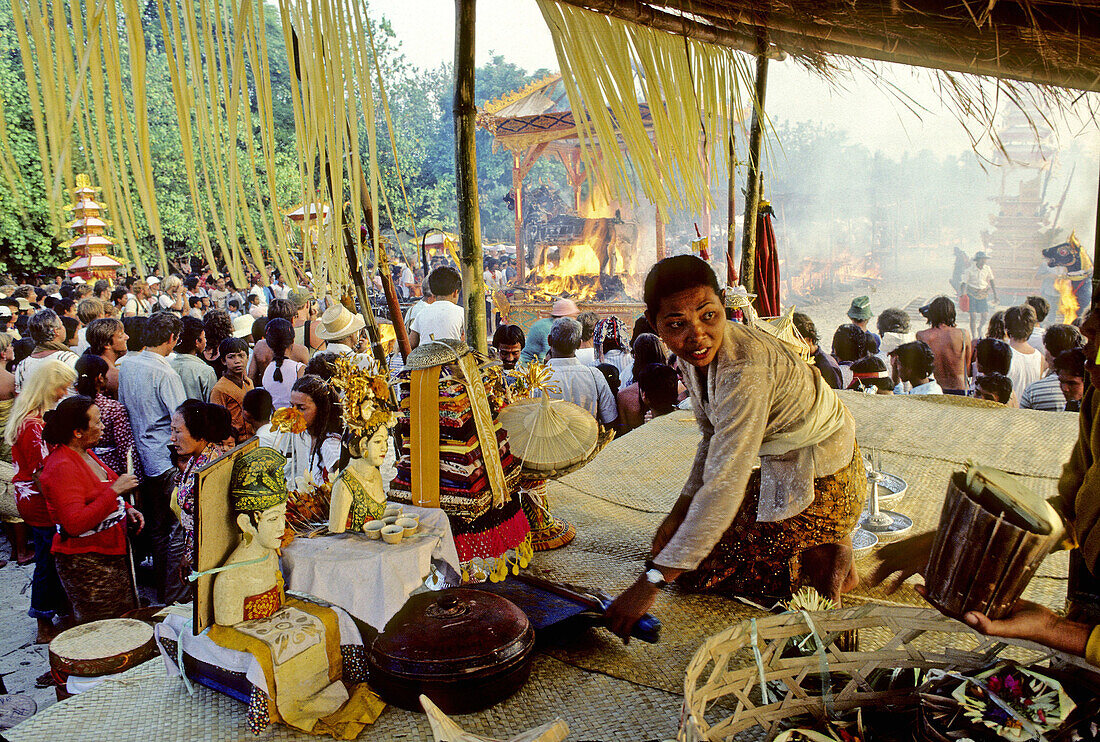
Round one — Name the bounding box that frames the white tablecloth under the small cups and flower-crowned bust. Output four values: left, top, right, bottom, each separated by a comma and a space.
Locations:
283, 505, 460, 631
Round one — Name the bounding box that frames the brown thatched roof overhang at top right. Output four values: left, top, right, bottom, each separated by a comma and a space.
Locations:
560, 0, 1100, 91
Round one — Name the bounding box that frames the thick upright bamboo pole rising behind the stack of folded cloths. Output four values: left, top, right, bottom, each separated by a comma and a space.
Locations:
453, 0, 488, 353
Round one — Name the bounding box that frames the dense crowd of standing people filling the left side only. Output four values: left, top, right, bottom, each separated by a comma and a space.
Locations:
0, 268, 396, 642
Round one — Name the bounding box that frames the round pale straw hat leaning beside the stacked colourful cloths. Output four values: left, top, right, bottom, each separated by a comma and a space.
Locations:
499, 395, 600, 472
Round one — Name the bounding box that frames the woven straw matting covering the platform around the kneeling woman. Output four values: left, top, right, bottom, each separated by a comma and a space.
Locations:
8, 394, 1077, 742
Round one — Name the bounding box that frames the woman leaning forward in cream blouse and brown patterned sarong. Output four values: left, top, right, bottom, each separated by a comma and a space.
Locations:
607, 255, 867, 638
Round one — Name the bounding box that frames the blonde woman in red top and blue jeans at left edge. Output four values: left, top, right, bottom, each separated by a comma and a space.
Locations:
4, 361, 76, 644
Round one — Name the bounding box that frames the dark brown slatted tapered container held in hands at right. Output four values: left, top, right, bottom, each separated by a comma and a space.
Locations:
925, 473, 1057, 620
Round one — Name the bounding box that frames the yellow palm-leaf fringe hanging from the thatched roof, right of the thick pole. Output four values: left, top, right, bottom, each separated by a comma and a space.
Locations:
539, 0, 754, 218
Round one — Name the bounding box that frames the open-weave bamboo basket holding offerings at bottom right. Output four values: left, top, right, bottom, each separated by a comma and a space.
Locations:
677, 603, 1100, 742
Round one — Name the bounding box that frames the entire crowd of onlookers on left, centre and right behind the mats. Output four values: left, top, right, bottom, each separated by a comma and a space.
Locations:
0, 258, 1085, 655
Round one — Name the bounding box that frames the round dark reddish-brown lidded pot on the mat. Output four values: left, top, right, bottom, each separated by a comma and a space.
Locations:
369, 587, 535, 713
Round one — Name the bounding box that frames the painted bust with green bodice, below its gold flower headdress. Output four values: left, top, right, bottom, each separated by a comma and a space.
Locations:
329, 425, 389, 533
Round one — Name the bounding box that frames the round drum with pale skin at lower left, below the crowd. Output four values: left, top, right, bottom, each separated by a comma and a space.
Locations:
50, 619, 156, 685
